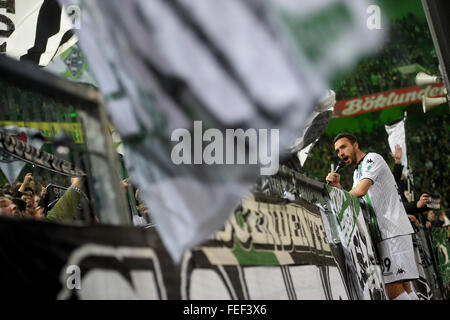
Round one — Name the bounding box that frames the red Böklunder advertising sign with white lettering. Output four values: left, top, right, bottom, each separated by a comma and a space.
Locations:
334, 83, 445, 117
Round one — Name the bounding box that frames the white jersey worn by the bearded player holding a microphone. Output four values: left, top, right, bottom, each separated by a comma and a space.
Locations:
353, 152, 414, 240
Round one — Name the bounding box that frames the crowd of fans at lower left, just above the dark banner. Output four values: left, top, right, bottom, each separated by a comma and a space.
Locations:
0, 170, 150, 226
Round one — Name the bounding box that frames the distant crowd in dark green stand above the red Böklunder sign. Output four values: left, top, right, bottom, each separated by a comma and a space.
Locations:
333, 14, 439, 100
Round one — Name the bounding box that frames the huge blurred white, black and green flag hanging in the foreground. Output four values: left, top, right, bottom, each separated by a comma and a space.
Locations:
60, 0, 381, 261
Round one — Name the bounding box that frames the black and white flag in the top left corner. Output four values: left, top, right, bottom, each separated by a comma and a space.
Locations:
0, 0, 79, 66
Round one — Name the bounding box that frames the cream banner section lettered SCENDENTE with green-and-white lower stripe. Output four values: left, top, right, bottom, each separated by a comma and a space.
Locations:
199, 196, 336, 266
